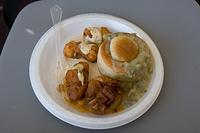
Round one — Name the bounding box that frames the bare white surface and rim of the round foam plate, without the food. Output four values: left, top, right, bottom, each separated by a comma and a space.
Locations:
29, 13, 164, 129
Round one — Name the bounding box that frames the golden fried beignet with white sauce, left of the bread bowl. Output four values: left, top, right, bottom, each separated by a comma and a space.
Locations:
63, 41, 98, 62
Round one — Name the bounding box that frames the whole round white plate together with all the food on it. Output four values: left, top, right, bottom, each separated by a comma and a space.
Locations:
29, 13, 164, 129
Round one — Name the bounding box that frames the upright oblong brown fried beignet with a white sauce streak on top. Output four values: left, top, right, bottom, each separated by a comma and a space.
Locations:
65, 62, 89, 101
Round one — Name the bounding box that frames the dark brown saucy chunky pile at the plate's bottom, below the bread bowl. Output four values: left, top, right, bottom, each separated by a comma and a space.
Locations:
85, 76, 121, 114
